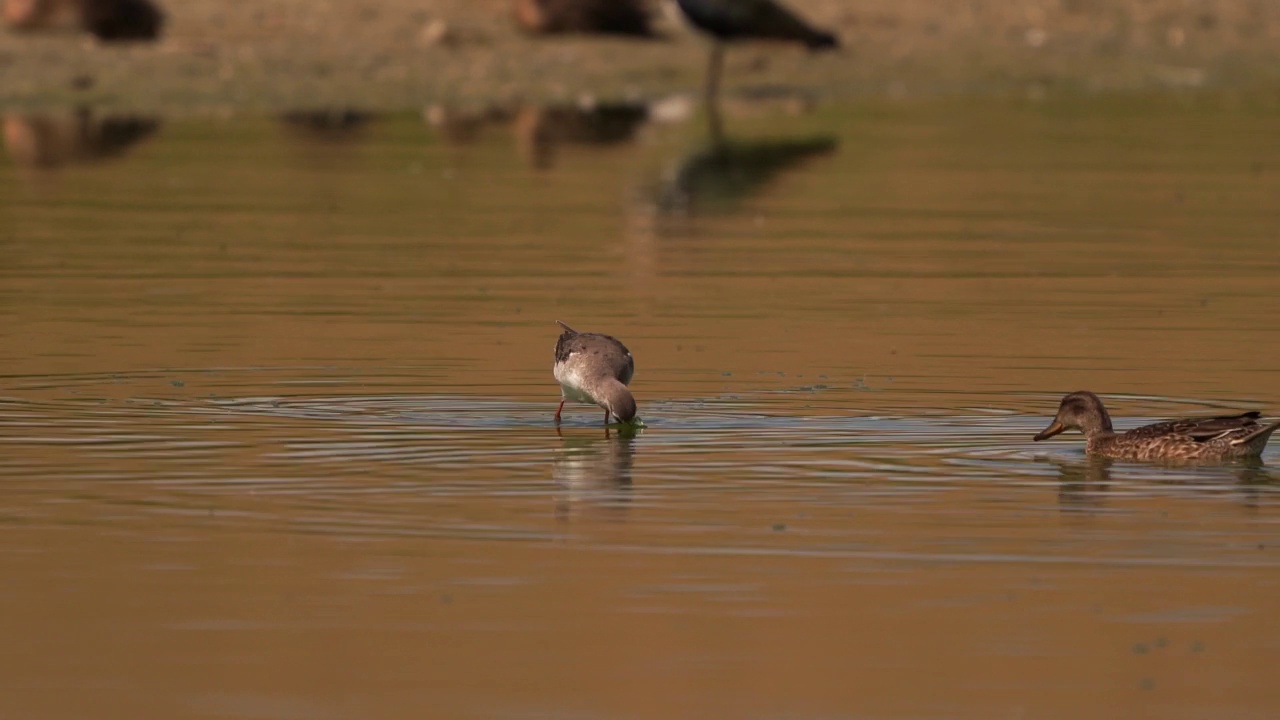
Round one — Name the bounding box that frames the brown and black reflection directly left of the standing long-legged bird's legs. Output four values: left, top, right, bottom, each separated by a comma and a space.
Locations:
515, 102, 649, 169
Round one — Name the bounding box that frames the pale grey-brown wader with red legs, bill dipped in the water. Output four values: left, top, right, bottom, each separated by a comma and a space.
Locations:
552, 320, 636, 424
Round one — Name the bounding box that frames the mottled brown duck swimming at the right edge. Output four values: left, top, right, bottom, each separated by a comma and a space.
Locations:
1034, 391, 1280, 460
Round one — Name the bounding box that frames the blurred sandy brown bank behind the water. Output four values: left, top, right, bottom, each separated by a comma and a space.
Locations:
0, 0, 1280, 111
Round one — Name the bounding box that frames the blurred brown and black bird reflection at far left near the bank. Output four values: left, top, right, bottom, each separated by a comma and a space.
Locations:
4, 109, 160, 169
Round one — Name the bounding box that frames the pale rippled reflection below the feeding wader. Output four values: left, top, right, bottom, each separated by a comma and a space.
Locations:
552, 428, 635, 520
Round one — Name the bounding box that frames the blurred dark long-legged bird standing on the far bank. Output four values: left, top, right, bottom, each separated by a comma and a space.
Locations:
676, 0, 840, 102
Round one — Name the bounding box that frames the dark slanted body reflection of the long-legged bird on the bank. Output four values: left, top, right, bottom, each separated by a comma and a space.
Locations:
655, 126, 838, 217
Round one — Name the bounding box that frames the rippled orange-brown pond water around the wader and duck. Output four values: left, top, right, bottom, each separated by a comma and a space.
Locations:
0, 99, 1280, 719
